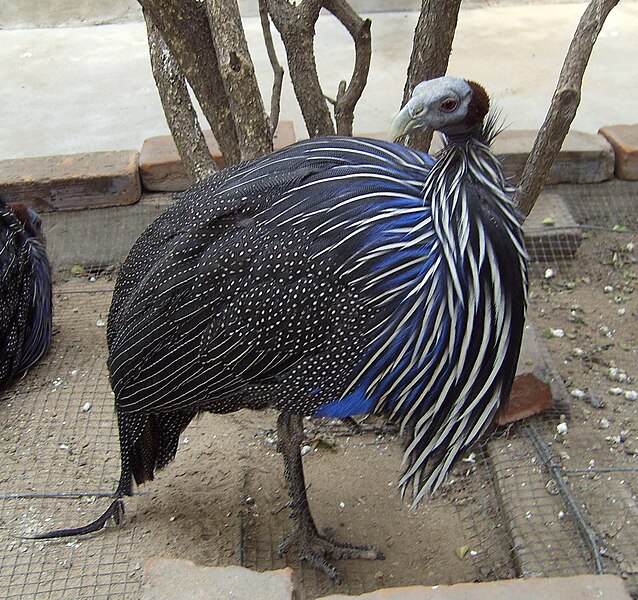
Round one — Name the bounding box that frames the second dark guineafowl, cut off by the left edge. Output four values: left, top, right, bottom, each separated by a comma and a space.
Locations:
0, 200, 52, 387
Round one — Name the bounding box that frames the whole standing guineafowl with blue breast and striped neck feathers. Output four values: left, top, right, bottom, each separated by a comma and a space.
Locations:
40, 77, 527, 579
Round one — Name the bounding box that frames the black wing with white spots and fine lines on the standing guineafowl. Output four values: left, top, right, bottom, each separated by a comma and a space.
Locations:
109, 164, 370, 412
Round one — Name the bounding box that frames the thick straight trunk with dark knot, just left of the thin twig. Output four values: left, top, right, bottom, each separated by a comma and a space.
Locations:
207, 0, 273, 160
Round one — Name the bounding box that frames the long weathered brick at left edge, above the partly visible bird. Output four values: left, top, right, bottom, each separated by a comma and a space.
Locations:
0, 150, 142, 212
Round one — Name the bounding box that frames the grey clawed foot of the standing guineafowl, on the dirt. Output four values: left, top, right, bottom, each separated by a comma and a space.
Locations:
278, 528, 385, 584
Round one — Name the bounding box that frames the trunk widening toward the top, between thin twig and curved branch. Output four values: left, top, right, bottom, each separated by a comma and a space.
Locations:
266, 0, 335, 137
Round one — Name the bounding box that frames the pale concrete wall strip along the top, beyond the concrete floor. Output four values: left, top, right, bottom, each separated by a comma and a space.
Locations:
0, 0, 421, 29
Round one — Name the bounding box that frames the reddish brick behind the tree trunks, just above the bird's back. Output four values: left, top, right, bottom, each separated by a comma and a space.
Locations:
140, 121, 295, 192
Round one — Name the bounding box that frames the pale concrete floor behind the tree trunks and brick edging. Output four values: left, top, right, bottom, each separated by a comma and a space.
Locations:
0, 0, 638, 159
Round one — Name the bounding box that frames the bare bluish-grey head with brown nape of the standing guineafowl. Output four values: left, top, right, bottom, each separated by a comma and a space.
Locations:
388, 77, 490, 141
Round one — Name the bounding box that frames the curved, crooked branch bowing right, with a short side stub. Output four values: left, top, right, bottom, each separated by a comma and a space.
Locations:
324, 0, 372, 135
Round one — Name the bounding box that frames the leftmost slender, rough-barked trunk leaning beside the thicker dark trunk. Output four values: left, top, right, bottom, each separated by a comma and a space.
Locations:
143, 11, 217, 180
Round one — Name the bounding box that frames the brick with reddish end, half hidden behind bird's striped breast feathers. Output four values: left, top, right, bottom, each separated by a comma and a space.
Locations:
496, 325, 554, 425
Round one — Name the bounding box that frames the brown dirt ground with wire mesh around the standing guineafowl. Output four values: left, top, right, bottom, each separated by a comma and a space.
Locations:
0, 181, 638, 599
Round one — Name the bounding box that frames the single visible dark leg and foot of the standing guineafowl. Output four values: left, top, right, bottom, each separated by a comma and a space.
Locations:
277, 412, 384, 583
